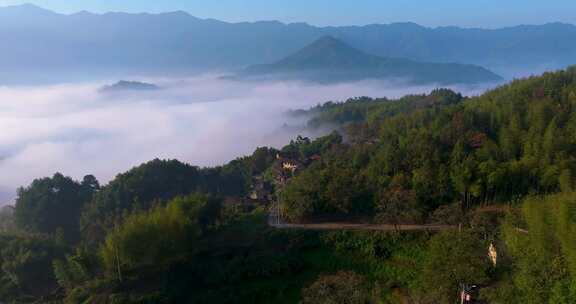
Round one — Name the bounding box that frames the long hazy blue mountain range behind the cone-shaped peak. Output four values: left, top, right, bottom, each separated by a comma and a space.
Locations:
0, 5, 576, 79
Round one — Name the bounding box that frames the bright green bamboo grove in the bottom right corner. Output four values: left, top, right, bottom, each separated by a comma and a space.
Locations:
485, 192, 576, 304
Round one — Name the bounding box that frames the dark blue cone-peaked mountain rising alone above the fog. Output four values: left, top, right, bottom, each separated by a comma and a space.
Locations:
238, 36, 502, 84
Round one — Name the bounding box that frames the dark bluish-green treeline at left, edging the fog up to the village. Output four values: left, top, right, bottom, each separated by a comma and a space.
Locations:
9, 148, 276, 245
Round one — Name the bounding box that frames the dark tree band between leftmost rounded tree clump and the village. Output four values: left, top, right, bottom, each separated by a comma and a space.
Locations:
81, 148, 275, 244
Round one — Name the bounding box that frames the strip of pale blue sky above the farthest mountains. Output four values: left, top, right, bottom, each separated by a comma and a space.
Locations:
0, 0, 576, 28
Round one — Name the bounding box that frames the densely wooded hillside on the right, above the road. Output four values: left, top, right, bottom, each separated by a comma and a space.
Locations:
280, 67, 576, 221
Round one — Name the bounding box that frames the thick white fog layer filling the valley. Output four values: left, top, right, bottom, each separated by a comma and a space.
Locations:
0, 76, 496, 204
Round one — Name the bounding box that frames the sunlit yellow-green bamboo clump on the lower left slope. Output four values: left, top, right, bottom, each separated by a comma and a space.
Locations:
101, 194, 218, 274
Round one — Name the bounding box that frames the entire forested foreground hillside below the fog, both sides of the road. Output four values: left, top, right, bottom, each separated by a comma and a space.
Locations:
0, 68, 576, 304
